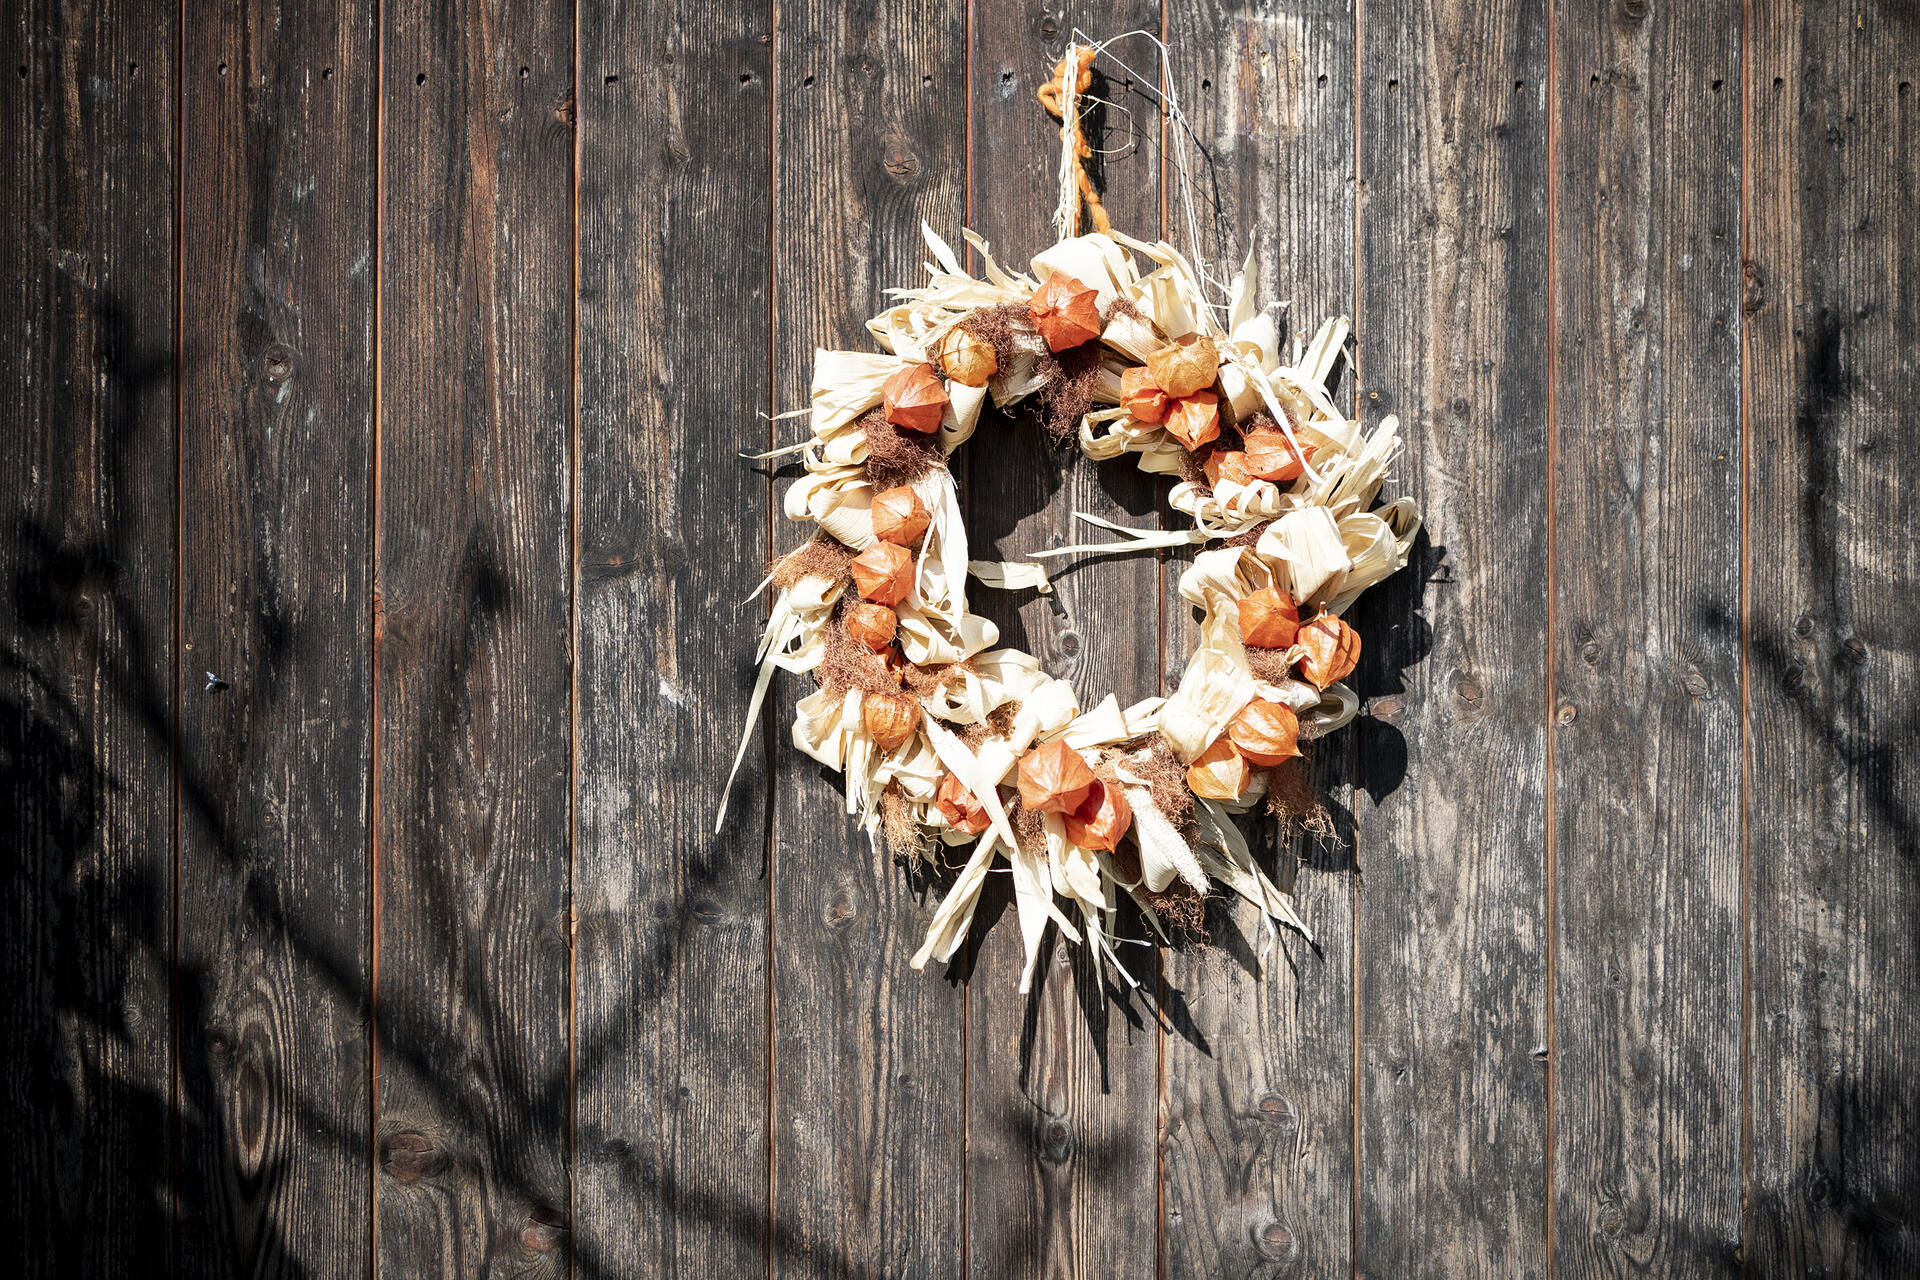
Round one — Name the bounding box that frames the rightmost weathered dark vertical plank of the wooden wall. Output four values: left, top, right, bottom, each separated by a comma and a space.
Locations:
1724, 4, 1920, 1276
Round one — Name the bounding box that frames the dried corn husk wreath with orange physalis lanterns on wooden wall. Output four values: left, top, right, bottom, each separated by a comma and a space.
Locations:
722, 35, 1419, 990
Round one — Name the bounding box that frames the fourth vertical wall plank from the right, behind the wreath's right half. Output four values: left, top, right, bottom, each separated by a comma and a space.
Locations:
1164, 0, 1356, 1276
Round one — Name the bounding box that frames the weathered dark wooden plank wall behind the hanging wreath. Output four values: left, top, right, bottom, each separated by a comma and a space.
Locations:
0, 0, 1920, 1280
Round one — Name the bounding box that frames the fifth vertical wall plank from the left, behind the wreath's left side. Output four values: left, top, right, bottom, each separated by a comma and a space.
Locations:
771, 0, 966, 1276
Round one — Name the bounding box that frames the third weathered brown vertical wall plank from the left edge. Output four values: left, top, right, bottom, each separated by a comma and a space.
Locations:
374, 0, 574, 1276
